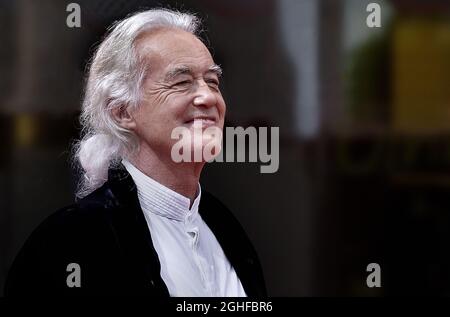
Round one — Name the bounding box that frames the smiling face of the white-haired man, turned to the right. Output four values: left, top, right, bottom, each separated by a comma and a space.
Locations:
132, 29, 226, 162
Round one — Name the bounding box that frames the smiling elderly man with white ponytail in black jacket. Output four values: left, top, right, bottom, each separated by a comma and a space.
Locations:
5, 9, 266, 297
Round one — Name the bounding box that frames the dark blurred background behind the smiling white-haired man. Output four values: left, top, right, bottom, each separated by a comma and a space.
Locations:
0, 0, 450, 296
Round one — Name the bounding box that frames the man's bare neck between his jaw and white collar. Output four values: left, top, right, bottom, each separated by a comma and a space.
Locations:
128, 147, 205, 206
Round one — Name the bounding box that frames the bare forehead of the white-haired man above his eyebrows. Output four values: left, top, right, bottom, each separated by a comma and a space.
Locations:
136, 28, 214, 76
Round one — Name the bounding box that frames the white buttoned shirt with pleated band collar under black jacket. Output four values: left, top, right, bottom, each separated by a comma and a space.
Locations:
122, 160, 246, 297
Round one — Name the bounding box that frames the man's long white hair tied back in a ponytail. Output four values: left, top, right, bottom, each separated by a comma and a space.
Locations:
74, 9, 200, 198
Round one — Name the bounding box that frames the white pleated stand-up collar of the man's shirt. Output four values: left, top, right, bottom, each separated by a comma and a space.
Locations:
122, 160, 202, 222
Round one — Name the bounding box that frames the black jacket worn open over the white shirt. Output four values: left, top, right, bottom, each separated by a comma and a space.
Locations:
5, 168, 267, 297
